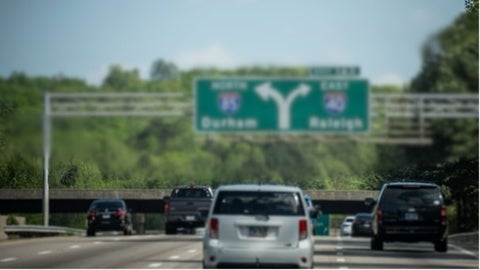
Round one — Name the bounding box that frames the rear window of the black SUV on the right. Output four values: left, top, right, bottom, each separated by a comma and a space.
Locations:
381, 186, 442, 205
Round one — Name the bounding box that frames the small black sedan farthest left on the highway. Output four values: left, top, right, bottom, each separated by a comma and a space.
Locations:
87, 199, 133, 236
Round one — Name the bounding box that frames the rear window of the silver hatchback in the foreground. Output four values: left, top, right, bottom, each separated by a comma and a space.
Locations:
213, 191, 305, 216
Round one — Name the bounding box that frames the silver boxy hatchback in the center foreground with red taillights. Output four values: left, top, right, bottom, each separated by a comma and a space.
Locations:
203, 184, 314, 268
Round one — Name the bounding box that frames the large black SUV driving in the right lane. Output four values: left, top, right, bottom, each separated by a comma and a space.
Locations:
365, 182, 448, 252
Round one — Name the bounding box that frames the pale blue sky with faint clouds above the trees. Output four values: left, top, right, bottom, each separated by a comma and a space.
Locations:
0, 0, 465, 85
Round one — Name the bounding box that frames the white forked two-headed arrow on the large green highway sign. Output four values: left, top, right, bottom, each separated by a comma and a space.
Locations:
255, 82, 311, 129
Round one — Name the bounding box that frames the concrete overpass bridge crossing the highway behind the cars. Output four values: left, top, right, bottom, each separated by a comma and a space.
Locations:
0, 189, 378, 214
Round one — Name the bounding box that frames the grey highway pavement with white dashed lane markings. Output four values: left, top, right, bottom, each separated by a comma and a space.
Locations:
0, 233, 479, 269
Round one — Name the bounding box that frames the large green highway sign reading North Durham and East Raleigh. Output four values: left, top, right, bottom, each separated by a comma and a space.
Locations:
193, 77, 370, 134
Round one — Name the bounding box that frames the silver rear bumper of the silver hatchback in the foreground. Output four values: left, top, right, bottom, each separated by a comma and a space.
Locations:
203, 240, 313, 268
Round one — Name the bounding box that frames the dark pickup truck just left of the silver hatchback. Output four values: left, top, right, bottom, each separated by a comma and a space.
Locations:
164, 186, 213, 234
